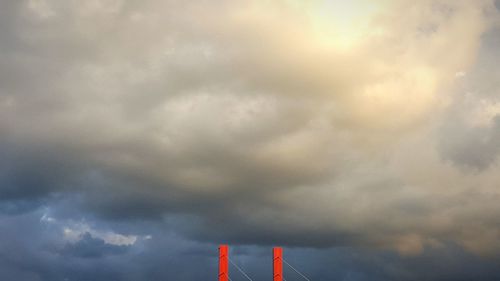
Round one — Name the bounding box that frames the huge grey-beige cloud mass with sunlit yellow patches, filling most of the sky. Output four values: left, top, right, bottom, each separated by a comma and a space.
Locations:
0, 1, 496, 245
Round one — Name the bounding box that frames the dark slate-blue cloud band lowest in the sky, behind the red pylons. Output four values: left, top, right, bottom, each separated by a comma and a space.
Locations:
0, 205, 500, 281
